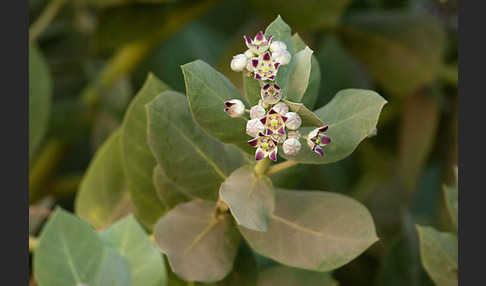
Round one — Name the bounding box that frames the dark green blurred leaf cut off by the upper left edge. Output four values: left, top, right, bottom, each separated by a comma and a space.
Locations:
29, 44, 52, 159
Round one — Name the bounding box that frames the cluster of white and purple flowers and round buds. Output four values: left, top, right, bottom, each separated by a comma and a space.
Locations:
224, 31, 331, 161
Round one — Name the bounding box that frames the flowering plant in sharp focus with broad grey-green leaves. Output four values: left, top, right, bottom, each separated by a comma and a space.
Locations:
34, 17, 386, 285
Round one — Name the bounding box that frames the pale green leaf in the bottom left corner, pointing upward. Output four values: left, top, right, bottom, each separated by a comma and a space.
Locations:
33, 208, 130, 286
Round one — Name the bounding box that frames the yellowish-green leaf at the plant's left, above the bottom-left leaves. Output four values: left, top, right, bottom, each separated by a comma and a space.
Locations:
75, 129, 133, 228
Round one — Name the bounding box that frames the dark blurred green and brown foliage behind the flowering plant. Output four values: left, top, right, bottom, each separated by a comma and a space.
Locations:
29, 0, 458, 286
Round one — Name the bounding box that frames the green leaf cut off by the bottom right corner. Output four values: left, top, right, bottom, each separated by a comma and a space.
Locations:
417, 225, 458, 286
